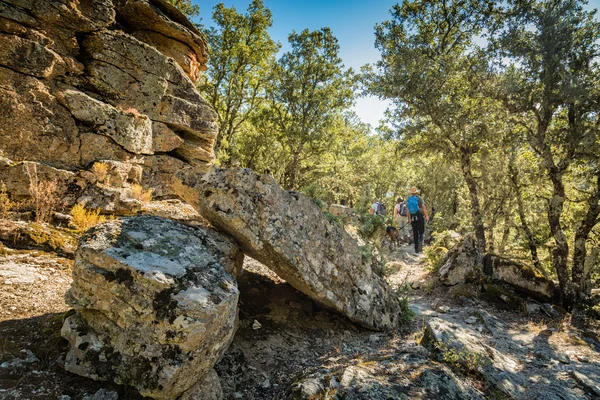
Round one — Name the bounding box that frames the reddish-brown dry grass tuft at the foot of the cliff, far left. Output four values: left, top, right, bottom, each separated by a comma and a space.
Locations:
24, 164, 62, 222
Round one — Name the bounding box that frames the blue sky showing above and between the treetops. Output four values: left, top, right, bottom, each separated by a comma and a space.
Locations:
193, 0, 600, 127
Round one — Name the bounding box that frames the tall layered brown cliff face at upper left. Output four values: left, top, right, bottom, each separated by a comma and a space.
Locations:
0, 0, 217, 212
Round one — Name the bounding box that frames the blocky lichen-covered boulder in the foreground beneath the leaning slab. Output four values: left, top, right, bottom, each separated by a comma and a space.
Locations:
62, 216, 243, 399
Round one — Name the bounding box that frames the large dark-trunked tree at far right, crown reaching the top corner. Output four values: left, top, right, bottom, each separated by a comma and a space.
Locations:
491, 0, 600, 307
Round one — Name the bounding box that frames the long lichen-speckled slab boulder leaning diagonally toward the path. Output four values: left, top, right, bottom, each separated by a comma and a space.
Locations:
175, 167, 401, 329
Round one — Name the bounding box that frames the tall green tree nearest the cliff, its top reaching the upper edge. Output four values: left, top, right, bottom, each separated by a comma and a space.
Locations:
200, 0, 279, 163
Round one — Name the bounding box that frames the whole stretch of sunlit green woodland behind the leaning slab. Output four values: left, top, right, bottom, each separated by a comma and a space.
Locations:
201, 0, 600, 302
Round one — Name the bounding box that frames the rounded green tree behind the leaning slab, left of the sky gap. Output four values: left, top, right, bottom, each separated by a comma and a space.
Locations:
269, 28, 355, 189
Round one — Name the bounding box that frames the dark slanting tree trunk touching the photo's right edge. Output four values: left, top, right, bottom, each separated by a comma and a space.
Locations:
572, 170, 600, 294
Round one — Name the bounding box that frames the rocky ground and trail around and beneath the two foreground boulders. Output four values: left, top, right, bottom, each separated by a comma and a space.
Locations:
0, 233, 600, 400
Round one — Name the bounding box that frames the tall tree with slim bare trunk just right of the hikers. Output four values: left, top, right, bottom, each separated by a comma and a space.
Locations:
367, 0, 498, 257
